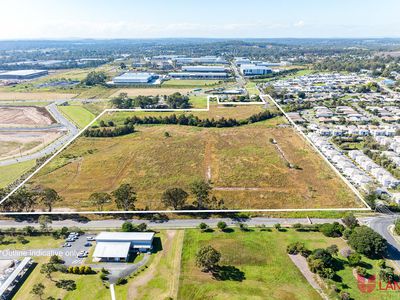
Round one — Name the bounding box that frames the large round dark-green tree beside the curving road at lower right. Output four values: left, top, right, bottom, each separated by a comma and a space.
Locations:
348, 226, 387, 258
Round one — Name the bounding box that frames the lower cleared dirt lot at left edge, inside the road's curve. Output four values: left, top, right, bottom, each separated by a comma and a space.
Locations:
0, 131, 61, 160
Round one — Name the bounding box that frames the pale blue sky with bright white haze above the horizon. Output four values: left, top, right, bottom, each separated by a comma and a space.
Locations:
0, 0, 400, 40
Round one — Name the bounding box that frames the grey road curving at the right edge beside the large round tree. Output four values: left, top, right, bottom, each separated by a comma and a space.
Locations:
361, 215, 400, 270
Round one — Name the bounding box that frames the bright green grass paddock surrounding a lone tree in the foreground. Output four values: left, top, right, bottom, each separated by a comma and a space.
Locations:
178, 228, 344, 300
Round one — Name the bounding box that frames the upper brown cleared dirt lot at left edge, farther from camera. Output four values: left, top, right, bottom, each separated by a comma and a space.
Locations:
0, 106, 55, 127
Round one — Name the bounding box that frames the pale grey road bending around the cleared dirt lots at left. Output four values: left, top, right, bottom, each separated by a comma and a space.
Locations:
0, 103, 79, 166
